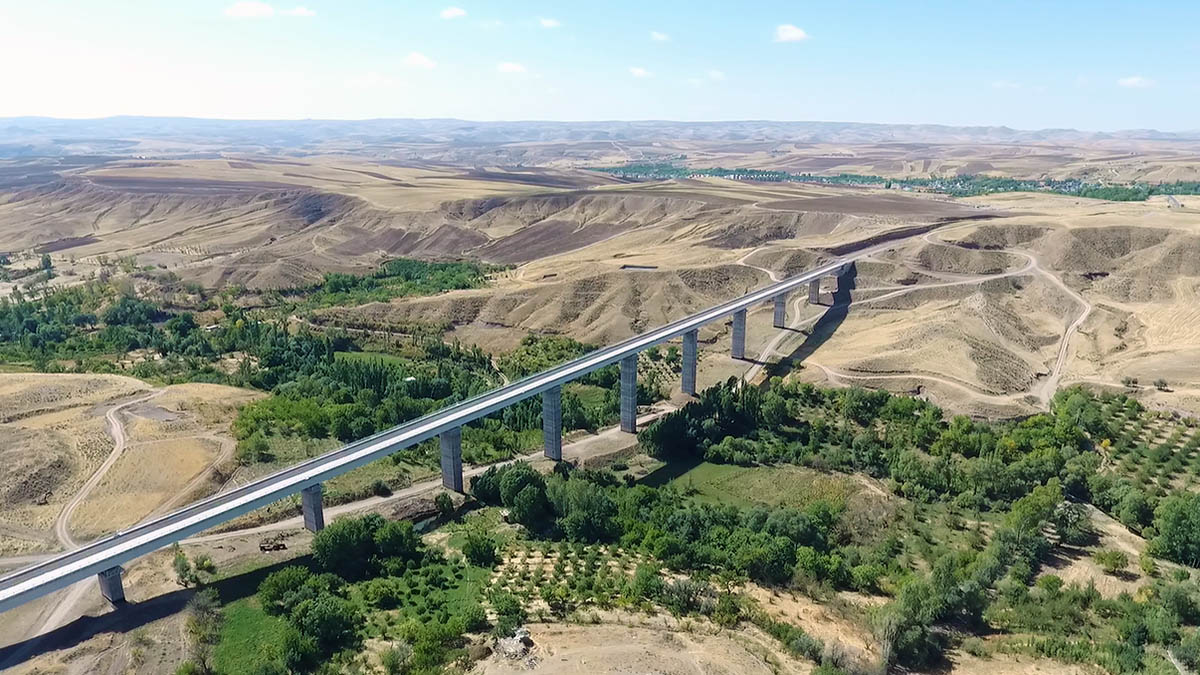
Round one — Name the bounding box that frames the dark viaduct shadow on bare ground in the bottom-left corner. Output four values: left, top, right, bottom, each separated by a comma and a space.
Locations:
0, 555, 312, 668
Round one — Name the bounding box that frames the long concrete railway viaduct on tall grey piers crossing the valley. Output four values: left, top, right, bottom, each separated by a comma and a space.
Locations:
0, 260, 866, 611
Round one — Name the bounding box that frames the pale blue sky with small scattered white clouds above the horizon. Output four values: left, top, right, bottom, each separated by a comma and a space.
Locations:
0, 0, 1200, 130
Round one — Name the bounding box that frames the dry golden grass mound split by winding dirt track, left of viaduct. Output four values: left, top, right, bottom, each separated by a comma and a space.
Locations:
0, 374, 262, 554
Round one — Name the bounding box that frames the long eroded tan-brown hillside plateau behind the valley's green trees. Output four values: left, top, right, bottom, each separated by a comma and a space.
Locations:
0, 157, 980, 288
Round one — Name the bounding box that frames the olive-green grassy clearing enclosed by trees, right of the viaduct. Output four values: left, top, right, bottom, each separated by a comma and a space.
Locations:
643, 461, 858, 507
